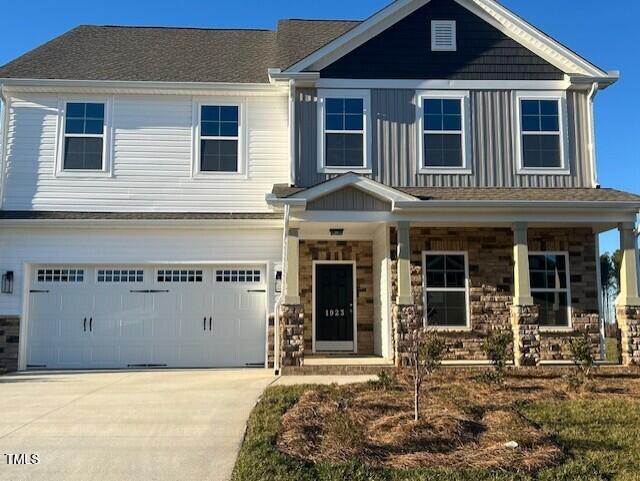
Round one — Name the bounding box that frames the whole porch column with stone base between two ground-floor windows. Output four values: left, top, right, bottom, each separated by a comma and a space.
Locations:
511, 223, 540, 367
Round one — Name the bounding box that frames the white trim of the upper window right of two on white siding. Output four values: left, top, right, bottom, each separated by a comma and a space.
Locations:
191, 97, 249, 179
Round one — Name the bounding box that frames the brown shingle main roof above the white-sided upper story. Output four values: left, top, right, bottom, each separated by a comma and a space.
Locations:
0, 20, 358, 83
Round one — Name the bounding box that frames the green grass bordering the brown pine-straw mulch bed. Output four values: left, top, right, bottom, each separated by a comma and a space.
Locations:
233, 379, 640, 481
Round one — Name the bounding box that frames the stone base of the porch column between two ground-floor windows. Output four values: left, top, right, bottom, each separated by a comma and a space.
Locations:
511, 306, 540, 367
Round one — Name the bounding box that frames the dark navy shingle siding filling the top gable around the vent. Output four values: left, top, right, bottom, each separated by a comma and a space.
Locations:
320, 0, 563, 80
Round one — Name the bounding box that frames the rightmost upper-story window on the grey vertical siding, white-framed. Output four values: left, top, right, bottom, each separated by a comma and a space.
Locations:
517, 93, 569, 174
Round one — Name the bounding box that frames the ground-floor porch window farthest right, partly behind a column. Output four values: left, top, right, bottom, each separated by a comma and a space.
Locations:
529, 252, 570, 328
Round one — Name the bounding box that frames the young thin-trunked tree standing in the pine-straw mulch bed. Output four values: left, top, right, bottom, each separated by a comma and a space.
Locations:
407, 328, 446, 422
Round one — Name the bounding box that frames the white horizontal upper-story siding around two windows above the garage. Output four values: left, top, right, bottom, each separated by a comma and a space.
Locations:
2, 94, 289, 213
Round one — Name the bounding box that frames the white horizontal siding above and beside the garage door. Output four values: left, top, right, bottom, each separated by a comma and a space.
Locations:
0, 226, 282, 316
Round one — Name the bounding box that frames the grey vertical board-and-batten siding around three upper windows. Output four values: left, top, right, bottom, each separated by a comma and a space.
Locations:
296, 89, 592, 187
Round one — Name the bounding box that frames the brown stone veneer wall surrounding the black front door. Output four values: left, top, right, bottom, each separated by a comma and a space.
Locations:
299, 240, 374, 354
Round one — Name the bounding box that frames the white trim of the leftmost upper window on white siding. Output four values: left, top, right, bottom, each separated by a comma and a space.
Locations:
54, 97, 114, 178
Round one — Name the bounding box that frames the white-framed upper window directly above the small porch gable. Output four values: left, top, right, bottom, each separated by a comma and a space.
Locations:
318, 91, 370, 173
